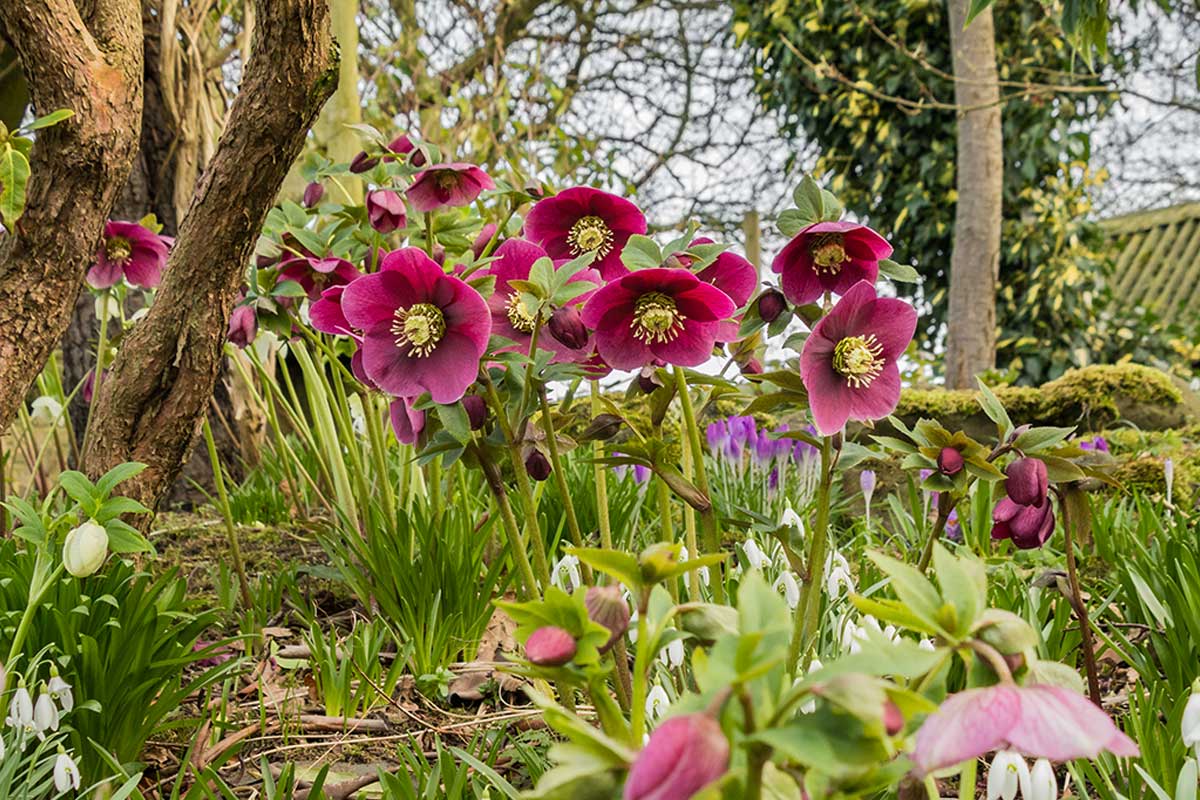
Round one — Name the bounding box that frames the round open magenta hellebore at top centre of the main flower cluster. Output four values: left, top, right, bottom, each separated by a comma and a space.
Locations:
524, 186, 646, 281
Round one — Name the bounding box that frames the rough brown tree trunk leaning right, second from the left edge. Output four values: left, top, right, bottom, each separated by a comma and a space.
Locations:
84, 0, 337, 509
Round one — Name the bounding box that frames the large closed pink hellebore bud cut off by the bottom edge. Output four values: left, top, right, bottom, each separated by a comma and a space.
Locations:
624, 714, 730, 800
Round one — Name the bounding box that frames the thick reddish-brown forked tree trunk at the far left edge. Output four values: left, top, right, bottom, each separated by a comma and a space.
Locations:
0, 0, 142, 431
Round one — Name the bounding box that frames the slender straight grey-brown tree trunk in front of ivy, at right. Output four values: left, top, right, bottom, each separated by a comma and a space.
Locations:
946, 0, 1004, 389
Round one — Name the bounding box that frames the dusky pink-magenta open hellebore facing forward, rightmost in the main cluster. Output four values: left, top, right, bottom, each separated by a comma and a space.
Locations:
800, 281, 917, 435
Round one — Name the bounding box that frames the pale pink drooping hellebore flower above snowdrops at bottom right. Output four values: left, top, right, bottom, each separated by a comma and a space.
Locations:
912, 684, 1138, 774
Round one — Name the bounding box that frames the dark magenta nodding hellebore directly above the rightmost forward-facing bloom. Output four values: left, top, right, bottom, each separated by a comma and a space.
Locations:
770, 222, 892, 306
